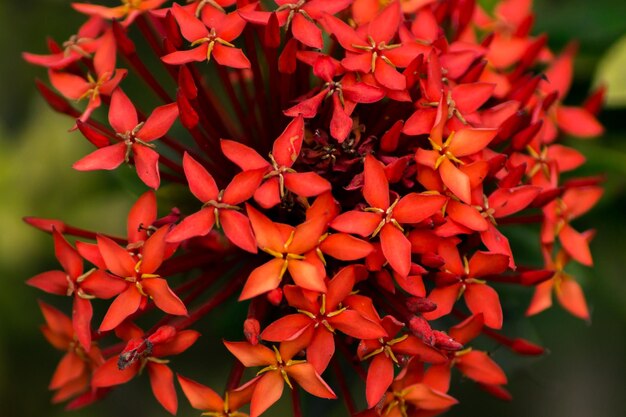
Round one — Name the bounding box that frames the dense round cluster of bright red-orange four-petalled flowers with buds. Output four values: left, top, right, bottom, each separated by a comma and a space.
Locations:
24, 0, 603, 417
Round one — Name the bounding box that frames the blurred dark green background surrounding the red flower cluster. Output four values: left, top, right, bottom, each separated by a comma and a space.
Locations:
0, 0, 626, 417
